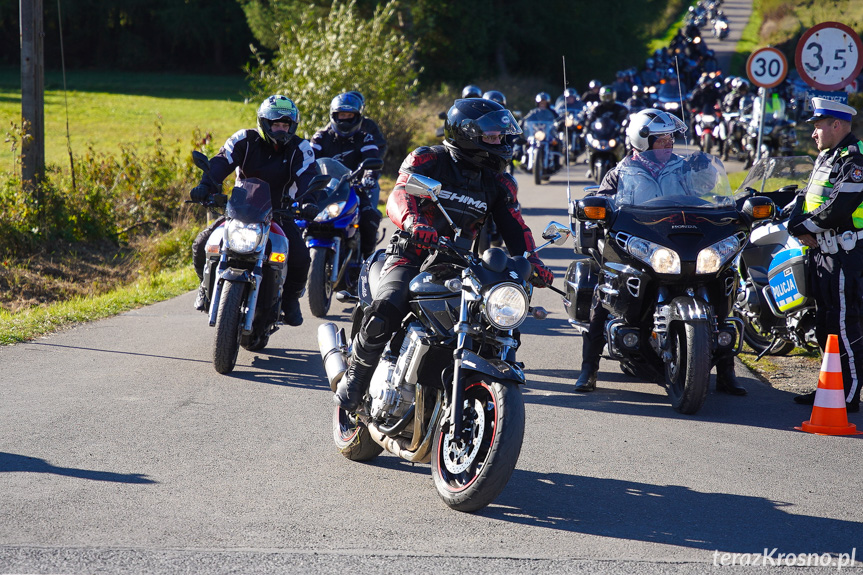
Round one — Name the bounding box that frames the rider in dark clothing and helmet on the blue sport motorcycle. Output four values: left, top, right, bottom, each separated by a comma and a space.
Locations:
312, 92, 381, 258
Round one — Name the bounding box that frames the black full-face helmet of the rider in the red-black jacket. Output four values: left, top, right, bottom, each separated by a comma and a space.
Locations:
443, 98, 521, 172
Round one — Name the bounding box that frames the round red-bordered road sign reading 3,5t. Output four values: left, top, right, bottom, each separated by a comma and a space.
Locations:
794, 22, 863, 91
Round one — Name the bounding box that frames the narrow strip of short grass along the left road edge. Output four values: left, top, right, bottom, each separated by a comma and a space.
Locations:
0, 266, 198, 345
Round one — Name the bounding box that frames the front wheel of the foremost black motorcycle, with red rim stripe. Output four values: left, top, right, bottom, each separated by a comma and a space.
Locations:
431, 375, 524, 513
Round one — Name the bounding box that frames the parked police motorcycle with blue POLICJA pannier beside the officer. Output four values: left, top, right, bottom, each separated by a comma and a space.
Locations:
734, 156, 818, 359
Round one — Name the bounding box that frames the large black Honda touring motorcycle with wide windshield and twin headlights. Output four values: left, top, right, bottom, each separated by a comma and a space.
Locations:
564, 151, 774, 414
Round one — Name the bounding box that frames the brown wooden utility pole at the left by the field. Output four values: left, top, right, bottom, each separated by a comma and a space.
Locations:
18, 0, 45, 190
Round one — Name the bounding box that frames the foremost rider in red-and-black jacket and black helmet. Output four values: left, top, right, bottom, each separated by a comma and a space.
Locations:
333, 99, 554, 411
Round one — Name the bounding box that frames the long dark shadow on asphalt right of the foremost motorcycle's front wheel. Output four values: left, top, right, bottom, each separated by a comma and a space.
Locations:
480, 469, 863, 553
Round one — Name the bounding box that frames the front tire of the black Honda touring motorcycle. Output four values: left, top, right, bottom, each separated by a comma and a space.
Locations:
665, 321, 711, 415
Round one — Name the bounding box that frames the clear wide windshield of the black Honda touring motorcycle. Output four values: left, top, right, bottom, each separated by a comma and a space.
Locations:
614, 150, 734, 209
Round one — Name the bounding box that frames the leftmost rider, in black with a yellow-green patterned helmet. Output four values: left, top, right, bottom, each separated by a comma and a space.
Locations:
189, 94, 318, 326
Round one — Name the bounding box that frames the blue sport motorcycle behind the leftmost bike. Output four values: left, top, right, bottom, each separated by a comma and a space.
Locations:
297, 158, 383, 317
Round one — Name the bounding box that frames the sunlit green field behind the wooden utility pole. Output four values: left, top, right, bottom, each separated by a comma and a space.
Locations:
0, 69, 256, 171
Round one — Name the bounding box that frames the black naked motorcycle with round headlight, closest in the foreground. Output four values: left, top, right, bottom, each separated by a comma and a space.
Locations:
318, 174, 569, 512
